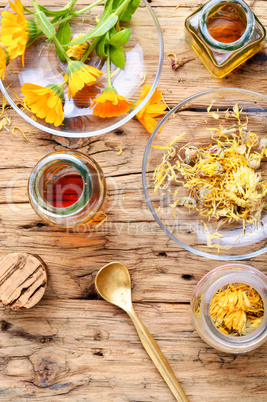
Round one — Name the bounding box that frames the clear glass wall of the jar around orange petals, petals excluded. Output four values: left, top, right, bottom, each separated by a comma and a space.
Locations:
191, 264, 267, 353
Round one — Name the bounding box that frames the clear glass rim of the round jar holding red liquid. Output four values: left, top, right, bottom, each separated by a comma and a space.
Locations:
28, 151, 92, 220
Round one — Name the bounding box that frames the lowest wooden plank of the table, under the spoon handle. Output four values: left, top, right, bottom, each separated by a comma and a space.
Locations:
0, 300, 267, 402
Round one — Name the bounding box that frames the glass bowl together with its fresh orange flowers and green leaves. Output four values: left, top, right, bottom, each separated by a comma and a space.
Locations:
0, 0, 163, 137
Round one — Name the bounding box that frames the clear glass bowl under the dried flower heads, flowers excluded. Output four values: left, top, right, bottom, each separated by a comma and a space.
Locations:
142, 88, 267, 261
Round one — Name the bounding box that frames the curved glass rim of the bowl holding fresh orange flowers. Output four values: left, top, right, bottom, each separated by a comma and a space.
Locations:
0, 0, 164, 138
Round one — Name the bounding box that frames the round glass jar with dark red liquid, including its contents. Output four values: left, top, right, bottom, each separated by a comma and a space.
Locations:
28, 151, 106, 228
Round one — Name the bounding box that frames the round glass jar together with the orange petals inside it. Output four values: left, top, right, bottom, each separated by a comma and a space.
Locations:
191, 264, 267, 353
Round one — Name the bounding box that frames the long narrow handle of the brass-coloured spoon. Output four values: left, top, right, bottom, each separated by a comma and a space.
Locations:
127, 308, 189, 402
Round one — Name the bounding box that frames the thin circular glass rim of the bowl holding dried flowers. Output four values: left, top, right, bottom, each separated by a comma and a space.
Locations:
142, 87, 267, 261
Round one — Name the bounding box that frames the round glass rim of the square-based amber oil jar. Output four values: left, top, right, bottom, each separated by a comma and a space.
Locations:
199, 0, 255, 51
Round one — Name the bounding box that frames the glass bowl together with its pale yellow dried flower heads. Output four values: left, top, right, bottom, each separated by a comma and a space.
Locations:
143, 88, 267, 260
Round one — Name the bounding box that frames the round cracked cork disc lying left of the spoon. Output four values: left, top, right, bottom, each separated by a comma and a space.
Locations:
0, 253, 47, 310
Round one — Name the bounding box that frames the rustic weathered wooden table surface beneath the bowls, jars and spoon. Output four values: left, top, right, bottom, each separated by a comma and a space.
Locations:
0, 0, 267, 402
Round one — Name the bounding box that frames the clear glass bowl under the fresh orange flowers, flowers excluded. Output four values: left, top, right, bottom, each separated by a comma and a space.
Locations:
0, 0, 163, 138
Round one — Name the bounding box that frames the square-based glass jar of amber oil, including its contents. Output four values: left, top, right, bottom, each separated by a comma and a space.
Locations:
185, 0, 266, 78
